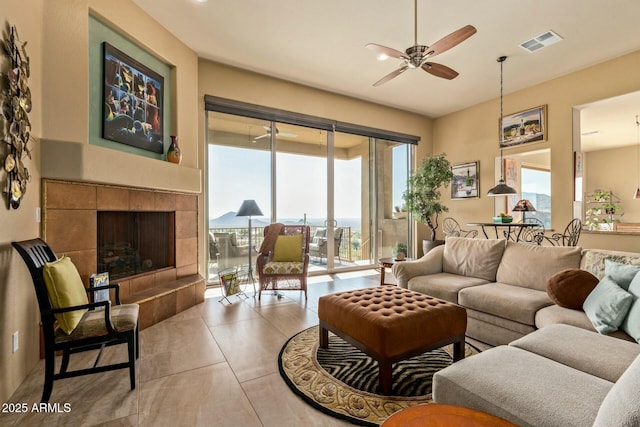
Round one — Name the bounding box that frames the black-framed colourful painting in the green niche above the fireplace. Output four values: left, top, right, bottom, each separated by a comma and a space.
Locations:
102, 42, 164, 154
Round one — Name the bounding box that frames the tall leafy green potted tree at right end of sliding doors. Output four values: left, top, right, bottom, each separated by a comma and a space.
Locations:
402, 153, 453, 253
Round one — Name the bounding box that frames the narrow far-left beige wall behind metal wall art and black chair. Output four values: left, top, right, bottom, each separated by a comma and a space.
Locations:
0, 0, 43, 402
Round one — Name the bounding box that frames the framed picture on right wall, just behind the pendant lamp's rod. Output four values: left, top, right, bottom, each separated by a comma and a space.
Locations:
500, 105, 547, 148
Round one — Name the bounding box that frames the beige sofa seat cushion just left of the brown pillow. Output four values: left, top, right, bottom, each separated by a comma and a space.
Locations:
458, 283, 553, 325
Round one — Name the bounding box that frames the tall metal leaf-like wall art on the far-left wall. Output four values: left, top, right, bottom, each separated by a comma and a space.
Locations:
0, 26, 33, 209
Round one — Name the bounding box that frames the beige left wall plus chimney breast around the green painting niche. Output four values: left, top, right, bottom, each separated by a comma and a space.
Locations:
0, 0, 202, 402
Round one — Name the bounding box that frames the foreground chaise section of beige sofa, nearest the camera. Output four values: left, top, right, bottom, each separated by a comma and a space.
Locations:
433, 324, 640, 427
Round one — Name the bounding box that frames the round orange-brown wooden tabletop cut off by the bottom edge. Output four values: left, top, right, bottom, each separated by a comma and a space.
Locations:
380, 403, 517, 427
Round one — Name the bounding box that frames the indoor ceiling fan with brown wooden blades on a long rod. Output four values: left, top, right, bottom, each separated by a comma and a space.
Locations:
365, 0, 477, 86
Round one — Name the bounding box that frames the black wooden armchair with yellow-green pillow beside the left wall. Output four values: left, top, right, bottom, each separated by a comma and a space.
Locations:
11, 239, 139, 402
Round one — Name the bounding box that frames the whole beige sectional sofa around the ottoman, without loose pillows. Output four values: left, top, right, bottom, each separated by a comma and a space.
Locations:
393, 238, 640, 427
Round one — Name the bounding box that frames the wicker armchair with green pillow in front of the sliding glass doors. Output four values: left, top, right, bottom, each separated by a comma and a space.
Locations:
256, 225, 310, 300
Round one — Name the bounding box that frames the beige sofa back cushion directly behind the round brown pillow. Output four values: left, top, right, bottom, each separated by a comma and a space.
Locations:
496, 241, 582, 292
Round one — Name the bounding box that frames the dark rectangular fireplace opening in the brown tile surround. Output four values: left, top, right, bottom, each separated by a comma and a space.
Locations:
97, 211, 176, 279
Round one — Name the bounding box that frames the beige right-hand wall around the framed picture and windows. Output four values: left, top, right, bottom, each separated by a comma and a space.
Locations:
433, 51, 640, 251
